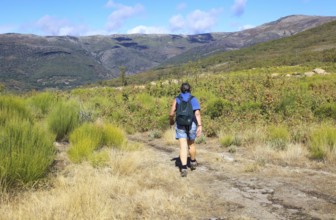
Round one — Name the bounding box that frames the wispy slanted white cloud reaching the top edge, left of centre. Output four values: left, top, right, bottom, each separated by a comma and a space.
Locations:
105, 0, 144, 31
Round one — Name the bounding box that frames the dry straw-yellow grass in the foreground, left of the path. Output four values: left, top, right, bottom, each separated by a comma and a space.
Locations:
0, 145, 203, 219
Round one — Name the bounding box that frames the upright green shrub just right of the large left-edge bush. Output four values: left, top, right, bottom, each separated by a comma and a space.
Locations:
48, 102, 80, 141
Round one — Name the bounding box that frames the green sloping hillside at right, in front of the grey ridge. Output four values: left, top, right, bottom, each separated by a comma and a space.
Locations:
119, 21, 336, 85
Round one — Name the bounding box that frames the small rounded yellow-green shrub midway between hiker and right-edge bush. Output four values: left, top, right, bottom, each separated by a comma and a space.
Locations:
267, 126, 290, 150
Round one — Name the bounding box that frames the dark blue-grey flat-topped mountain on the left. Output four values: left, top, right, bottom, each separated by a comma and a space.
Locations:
0, 34, 225, 89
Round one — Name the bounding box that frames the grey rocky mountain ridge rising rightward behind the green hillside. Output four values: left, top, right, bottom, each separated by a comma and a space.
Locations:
163, 15, 336, 64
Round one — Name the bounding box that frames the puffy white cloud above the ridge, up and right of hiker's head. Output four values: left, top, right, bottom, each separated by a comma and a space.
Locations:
169, 9, 222, 34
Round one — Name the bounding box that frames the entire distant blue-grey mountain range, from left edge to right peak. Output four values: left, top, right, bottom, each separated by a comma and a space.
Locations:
0, 16, 336, 90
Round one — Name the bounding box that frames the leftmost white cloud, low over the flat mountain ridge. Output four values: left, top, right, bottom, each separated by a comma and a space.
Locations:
34, 15, 88, 35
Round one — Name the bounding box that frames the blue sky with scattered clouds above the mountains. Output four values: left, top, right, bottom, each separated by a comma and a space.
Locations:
0, 0, 336, 36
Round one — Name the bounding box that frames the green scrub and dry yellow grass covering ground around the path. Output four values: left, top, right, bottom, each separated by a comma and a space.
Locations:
0, 20, 336, 219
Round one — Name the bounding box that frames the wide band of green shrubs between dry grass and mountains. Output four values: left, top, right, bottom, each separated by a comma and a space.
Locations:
0, 67, 336, 192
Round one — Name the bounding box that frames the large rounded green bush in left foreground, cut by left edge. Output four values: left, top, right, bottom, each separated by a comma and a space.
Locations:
0, 118, 55, 186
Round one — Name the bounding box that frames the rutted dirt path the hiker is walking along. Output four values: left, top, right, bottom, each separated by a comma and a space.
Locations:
129, 135, 336, 220
